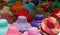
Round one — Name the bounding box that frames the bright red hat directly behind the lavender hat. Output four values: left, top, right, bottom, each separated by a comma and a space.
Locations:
14, 8, 32, 22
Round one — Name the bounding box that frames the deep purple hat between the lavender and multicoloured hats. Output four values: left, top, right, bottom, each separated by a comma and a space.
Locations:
31, 14, 44, 28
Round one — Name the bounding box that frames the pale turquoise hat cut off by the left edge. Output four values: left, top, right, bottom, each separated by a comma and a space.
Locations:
0, 19, 10, 35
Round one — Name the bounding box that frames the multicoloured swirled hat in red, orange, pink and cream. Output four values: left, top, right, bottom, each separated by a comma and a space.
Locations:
41, 17, 58, 35
